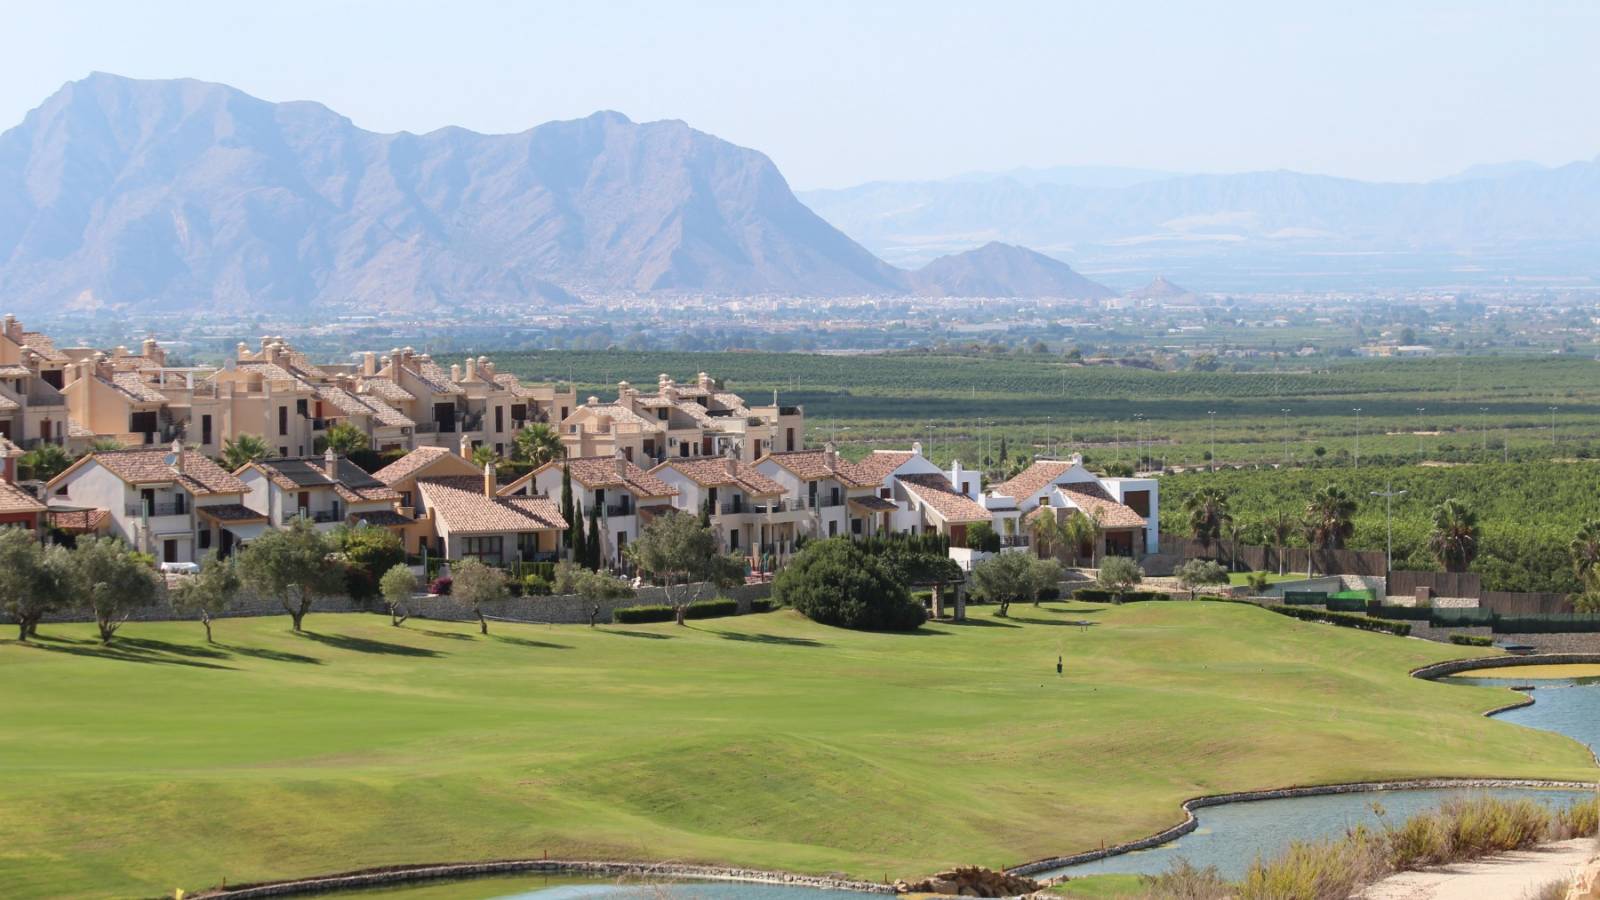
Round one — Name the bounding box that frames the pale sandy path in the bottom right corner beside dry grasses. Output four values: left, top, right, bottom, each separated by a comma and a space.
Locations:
1358, 838, 1595, 900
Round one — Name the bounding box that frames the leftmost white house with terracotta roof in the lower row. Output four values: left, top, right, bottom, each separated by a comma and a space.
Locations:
45, 442, 257, 562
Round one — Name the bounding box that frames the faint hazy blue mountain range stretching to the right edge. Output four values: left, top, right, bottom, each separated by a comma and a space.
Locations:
800, 160, 1600, 290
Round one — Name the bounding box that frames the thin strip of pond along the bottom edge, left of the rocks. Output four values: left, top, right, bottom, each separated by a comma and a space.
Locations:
320, 873, 886, 900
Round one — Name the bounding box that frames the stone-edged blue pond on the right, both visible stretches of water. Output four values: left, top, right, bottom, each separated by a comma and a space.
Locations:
1035, 668, 1600, 879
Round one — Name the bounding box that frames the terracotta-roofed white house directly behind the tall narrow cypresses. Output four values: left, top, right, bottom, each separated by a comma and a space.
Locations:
501, 455, 677, 567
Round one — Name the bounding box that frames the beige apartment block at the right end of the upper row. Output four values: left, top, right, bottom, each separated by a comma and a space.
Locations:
560, 372, 805, 464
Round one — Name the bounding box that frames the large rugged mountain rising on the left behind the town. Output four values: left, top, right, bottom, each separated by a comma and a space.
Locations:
0, 74, 909, 312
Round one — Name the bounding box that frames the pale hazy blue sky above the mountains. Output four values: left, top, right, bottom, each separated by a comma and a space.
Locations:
0, 0, 1600, 187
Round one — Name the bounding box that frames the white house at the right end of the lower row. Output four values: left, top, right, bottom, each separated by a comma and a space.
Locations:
984, 455, 1162, 559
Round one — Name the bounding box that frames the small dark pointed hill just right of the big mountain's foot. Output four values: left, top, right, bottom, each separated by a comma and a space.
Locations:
910, 242, 1117, 299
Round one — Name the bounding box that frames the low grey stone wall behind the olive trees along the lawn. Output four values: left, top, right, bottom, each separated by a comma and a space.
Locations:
0, 581, 773, 625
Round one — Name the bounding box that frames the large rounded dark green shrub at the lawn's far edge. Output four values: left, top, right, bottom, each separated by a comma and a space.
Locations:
773, 538, 928, 631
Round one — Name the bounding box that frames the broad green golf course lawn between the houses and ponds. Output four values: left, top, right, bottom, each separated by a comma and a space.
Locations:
0, 602, 1595, 897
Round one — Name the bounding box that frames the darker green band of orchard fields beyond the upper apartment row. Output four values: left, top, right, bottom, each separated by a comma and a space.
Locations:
496, 351, 1600, 471
